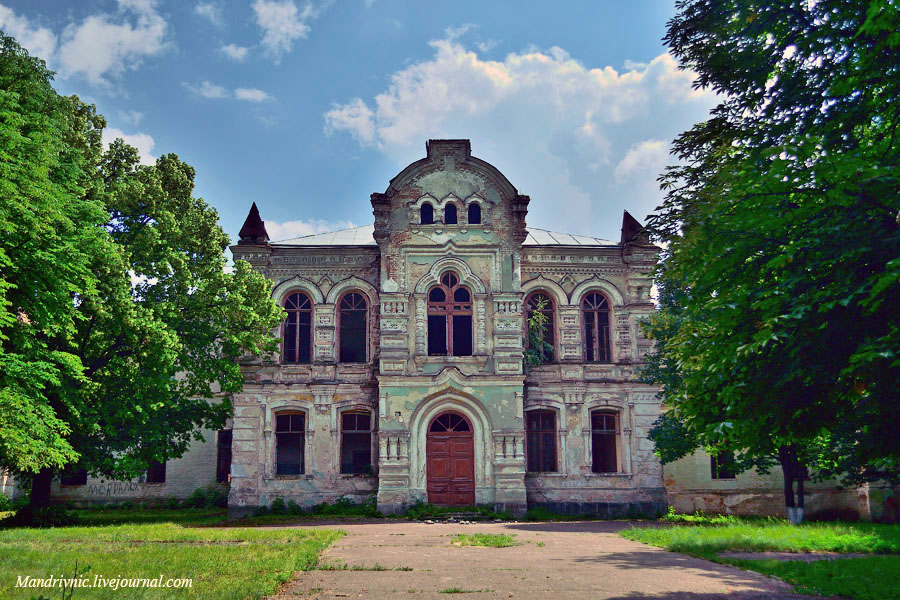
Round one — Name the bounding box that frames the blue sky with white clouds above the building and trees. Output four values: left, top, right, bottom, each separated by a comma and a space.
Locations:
0, 0, 715, 246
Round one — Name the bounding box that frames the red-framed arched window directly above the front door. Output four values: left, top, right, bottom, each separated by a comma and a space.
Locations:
428, 271, 472, 356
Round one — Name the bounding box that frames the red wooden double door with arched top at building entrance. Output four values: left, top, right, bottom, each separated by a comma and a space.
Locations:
425, 412, 475, 506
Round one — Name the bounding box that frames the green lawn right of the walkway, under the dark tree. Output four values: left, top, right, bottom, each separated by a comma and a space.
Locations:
622, 517, 900, 600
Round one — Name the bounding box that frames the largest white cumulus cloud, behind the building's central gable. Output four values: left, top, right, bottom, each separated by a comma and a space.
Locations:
324, 35, 715, 239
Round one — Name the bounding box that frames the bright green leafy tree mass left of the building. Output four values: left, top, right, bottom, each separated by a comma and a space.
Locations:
0, 32, 281, 506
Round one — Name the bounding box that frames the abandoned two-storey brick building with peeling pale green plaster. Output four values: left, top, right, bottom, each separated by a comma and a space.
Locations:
8, 140, 869, 517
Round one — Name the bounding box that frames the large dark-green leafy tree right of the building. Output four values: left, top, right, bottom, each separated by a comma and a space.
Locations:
649, 0, 900, 520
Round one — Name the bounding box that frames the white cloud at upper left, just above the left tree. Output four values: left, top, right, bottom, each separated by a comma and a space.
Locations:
59, 0, 168, 83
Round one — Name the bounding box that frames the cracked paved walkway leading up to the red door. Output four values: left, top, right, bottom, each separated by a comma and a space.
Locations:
277, 521, 810, 600
